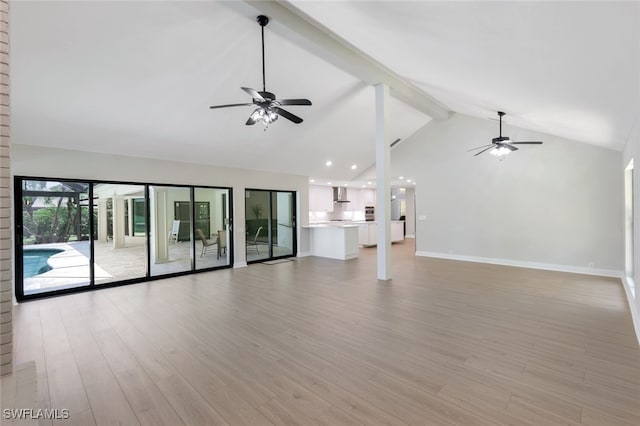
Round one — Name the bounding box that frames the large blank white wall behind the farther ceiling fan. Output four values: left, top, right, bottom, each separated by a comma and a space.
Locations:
393, 114, 624, 275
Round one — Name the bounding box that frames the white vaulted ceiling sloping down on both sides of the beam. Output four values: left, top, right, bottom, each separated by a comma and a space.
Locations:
10, 1, 640, 185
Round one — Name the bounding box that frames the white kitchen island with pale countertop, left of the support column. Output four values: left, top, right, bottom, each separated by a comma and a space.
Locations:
304, 222, 359, 260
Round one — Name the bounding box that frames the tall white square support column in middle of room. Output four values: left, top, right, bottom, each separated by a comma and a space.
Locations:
375, 84, 391, 280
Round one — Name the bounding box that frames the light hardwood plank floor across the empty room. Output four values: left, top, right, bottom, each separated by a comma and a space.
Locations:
10, 240, 640, 426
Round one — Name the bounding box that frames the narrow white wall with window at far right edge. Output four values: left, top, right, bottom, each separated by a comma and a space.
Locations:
618, 122, 640, 342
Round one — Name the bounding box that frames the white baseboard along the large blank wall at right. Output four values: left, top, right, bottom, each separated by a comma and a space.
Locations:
416, 251, 623, 278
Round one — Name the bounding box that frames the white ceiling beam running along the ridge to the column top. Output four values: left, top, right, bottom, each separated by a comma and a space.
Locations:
240, 0, 450, 120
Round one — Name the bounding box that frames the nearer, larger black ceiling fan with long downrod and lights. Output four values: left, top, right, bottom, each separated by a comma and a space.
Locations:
209, 15, 311, 130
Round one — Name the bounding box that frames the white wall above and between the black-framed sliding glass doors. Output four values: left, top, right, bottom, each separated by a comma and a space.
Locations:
11, 144, 309, 266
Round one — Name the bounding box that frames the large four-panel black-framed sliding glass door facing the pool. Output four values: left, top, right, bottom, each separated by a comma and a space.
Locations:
14, 177, 232, 301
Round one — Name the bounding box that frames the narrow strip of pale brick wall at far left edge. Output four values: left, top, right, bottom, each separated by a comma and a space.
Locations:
0, 0, 13, 375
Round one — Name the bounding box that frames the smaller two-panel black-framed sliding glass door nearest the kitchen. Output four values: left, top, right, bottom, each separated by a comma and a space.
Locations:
245, 189, 296, 263
